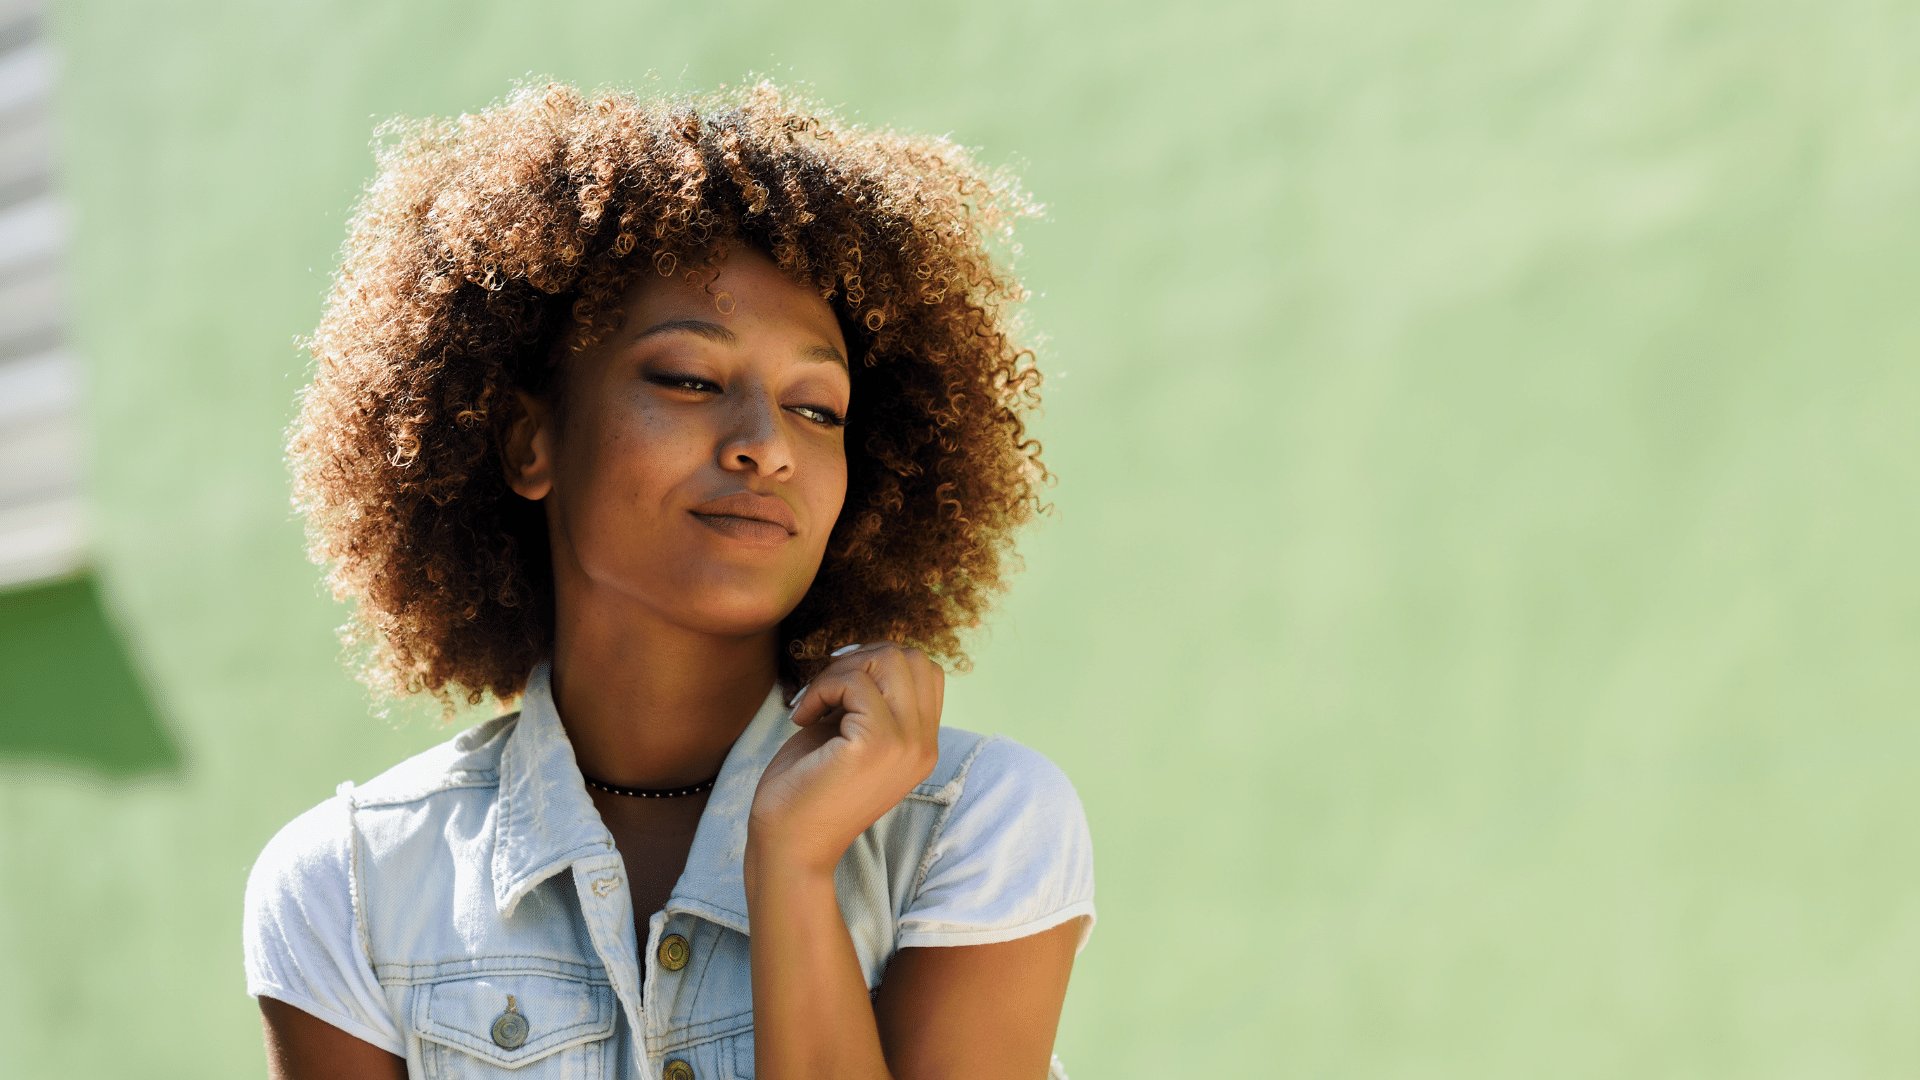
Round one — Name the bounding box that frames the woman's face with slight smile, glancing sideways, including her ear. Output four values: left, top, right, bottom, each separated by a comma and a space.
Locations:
507, 244, 852, 636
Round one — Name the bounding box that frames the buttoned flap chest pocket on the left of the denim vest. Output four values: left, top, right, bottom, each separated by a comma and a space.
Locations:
411, 972, 618, 1080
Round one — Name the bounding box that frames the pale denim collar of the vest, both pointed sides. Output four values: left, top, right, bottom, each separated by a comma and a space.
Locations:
492, 659, 799, 934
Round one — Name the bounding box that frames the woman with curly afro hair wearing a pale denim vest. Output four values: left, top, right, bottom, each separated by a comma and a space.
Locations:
246, 83, 1094, 1080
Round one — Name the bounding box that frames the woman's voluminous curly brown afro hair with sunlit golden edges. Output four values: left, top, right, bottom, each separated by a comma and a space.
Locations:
286, 81, 1052, 717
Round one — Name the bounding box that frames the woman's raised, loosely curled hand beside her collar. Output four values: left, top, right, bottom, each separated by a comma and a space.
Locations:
747, 642, 947, 874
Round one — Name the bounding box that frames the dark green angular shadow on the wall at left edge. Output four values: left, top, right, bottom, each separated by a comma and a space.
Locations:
0, 575, 180, 776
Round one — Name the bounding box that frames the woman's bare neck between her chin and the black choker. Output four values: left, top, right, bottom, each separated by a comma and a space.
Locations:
553, 584, 778, 788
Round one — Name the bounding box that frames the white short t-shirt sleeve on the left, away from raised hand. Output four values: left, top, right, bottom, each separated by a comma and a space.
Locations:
242, 796, 407, 1055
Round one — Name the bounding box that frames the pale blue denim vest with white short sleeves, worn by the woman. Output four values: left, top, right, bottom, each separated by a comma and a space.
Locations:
246, 661, 1094, 1080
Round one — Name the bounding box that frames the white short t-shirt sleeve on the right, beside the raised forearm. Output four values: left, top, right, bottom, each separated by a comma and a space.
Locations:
895, 736, 1094, 955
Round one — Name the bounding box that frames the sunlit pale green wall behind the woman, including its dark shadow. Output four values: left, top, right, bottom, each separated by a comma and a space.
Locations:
0, 0, 1920, 1080
